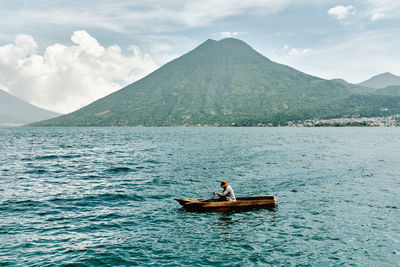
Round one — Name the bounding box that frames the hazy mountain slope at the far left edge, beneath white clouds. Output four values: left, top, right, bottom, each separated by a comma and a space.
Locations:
0, 90, 60, 126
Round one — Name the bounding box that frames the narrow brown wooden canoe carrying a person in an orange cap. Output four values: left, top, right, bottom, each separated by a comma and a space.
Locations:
174, 196, 277, 212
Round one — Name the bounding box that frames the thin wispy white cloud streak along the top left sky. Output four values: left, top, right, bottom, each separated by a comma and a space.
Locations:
0, 0, 293, 38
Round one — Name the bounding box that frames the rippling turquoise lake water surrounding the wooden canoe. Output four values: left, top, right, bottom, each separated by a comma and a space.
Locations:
0, 128, 400, 266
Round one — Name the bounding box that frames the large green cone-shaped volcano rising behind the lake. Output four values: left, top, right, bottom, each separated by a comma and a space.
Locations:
33, 38, 400, 126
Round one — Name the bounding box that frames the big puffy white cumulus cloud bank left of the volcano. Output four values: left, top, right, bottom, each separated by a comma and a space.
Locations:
0, 31, 157, 113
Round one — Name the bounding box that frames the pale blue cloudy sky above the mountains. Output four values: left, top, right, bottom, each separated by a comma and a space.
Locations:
0, 0, 400, 113
